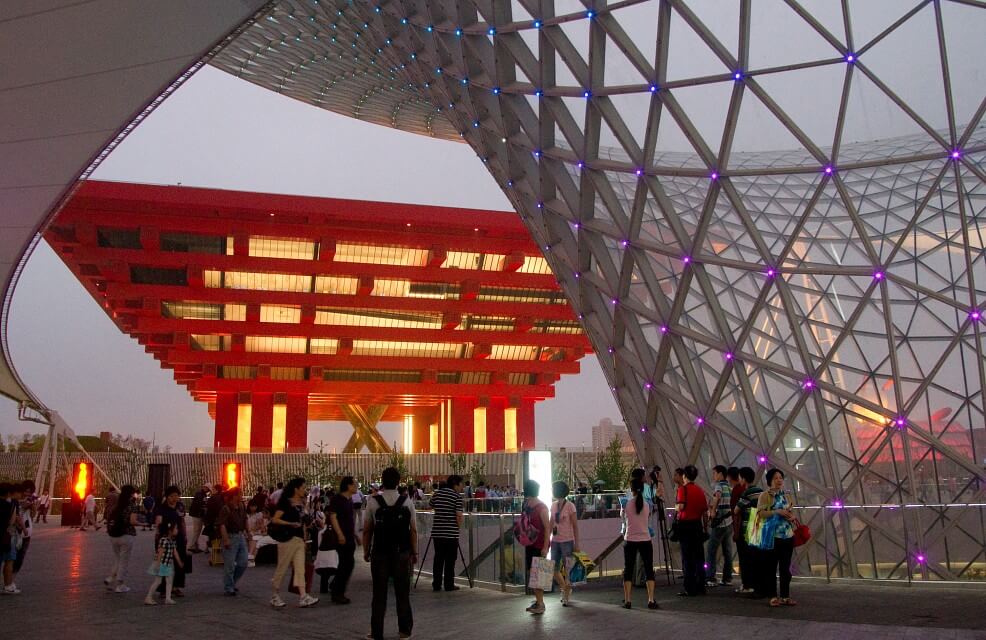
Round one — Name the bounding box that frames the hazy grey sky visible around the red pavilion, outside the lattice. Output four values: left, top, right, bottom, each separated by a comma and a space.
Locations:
0, 67, 619, 450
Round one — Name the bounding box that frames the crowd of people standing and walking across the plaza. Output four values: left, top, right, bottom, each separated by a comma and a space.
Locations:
0, 465, 797, 638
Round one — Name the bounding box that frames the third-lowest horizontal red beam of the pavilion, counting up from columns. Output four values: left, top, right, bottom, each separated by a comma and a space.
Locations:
131, 318, 587, 348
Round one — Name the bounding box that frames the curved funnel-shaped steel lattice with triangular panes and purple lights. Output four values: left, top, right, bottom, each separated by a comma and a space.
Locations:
212, 0, 986, 579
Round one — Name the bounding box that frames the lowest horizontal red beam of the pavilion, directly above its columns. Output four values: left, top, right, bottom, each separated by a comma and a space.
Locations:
192, 378, 555, 404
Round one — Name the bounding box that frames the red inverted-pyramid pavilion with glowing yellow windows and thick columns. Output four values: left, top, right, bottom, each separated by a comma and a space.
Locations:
45, 181, 590, 452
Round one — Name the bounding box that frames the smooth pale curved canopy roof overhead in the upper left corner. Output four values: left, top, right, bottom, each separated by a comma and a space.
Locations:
0, 0, 265, 406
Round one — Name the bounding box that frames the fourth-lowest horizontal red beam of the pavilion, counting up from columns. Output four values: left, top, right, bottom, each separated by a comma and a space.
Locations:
97, 282, 575, 320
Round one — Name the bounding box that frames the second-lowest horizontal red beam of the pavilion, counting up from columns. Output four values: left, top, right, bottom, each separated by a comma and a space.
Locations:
164, 349, 579, 375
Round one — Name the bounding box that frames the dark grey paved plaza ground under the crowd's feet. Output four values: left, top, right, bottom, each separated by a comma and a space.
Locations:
0, 524, 986, 640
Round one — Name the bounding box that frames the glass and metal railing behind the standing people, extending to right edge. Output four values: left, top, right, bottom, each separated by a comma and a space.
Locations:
410, 494, 986, 590
